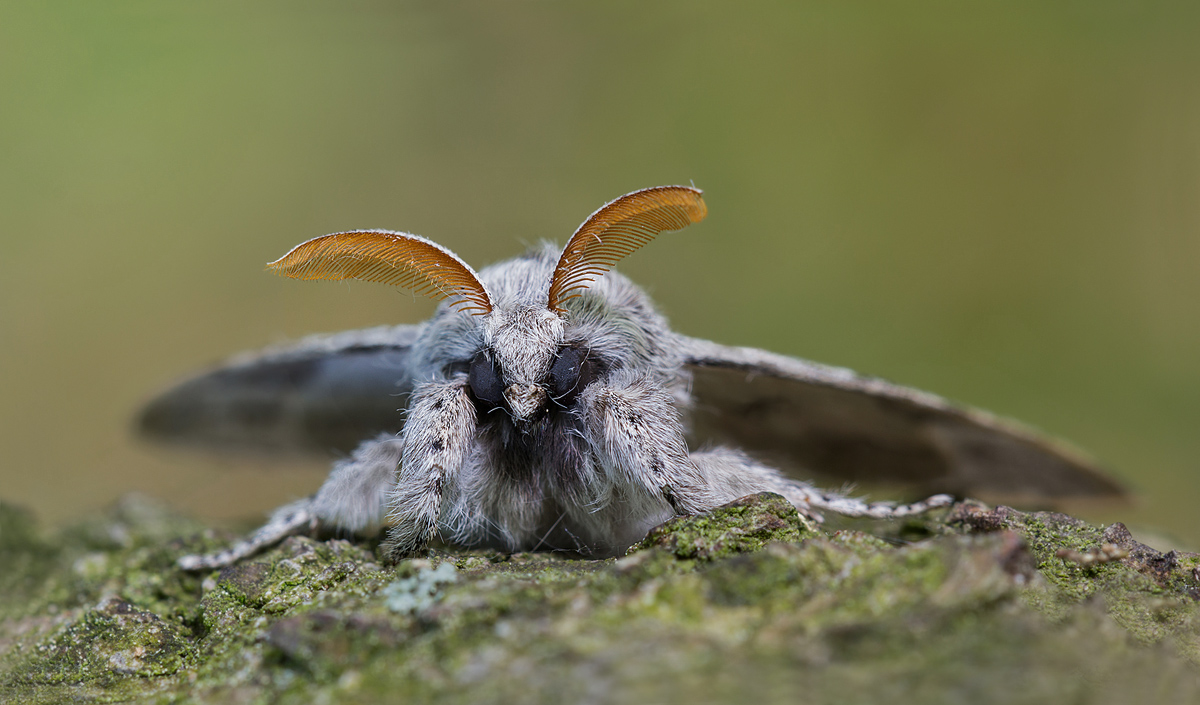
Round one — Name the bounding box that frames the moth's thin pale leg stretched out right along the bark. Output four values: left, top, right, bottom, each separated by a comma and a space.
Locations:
692, 448, 954, 522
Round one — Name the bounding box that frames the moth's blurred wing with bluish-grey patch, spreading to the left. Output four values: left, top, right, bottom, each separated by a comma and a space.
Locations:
138, 326, 421, 454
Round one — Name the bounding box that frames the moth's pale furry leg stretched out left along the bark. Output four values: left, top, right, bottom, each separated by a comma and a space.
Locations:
178, 435, 403, 571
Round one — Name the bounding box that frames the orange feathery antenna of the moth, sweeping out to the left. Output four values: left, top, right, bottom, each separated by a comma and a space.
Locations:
266, 230, 492, 315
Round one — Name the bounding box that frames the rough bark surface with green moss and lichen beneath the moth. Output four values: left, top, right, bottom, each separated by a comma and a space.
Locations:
0, 495, 1200, 703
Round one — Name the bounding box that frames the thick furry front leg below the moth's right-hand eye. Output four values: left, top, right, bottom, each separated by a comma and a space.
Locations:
576, 374, 721, 514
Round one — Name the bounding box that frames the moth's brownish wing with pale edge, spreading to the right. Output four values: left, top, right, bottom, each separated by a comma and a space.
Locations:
683, 338, 1127, 504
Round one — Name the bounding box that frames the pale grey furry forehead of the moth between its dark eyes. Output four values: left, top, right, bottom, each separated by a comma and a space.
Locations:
484, 306, 565, 385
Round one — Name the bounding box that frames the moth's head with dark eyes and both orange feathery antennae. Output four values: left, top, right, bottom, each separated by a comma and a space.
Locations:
268, 186, 708, 428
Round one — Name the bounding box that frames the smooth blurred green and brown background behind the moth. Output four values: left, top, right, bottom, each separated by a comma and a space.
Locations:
0, 1, 1200, 548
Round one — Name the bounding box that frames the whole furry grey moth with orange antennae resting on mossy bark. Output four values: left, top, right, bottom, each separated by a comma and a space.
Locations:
140, 186, 1123, 570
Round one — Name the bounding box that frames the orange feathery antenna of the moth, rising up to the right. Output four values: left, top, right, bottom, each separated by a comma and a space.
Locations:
547, 186, 708, 314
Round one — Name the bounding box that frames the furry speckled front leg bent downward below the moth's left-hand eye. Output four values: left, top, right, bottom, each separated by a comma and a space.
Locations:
384, 375, 475, 561
